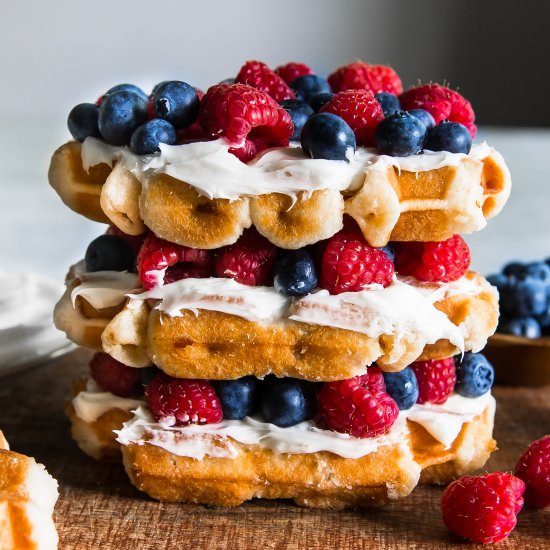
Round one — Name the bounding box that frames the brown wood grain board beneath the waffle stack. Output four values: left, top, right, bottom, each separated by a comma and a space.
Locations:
0, 350, 550, 550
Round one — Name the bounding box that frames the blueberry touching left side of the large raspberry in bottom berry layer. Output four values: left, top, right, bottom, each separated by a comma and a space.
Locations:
262, 377, 317, 428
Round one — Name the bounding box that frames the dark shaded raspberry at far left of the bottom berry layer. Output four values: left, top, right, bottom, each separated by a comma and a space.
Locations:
90, 352, 140, 397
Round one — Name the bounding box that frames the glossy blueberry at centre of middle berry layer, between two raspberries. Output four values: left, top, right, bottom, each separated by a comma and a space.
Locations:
274, 248, 317, 296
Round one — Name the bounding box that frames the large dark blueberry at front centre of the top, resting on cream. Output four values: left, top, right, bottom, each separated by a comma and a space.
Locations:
300, 113, 357, 162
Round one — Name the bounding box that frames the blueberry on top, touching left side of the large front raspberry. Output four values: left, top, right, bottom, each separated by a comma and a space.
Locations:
153, 80, 200, 128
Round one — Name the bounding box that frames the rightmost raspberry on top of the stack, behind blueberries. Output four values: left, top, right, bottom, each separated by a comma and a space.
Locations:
399, 84, 477, 139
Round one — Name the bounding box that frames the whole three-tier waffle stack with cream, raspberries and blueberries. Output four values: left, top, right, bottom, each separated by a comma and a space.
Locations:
49, 62, 511, 508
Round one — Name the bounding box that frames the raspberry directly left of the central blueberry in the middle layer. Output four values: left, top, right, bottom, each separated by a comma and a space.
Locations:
216, 229, 277, 286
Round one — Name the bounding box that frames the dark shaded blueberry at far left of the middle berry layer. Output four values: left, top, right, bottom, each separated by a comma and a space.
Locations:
84, 235, 136, 272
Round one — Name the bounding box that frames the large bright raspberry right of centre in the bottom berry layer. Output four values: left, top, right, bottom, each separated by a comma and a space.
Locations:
317, 367, 399, 438
